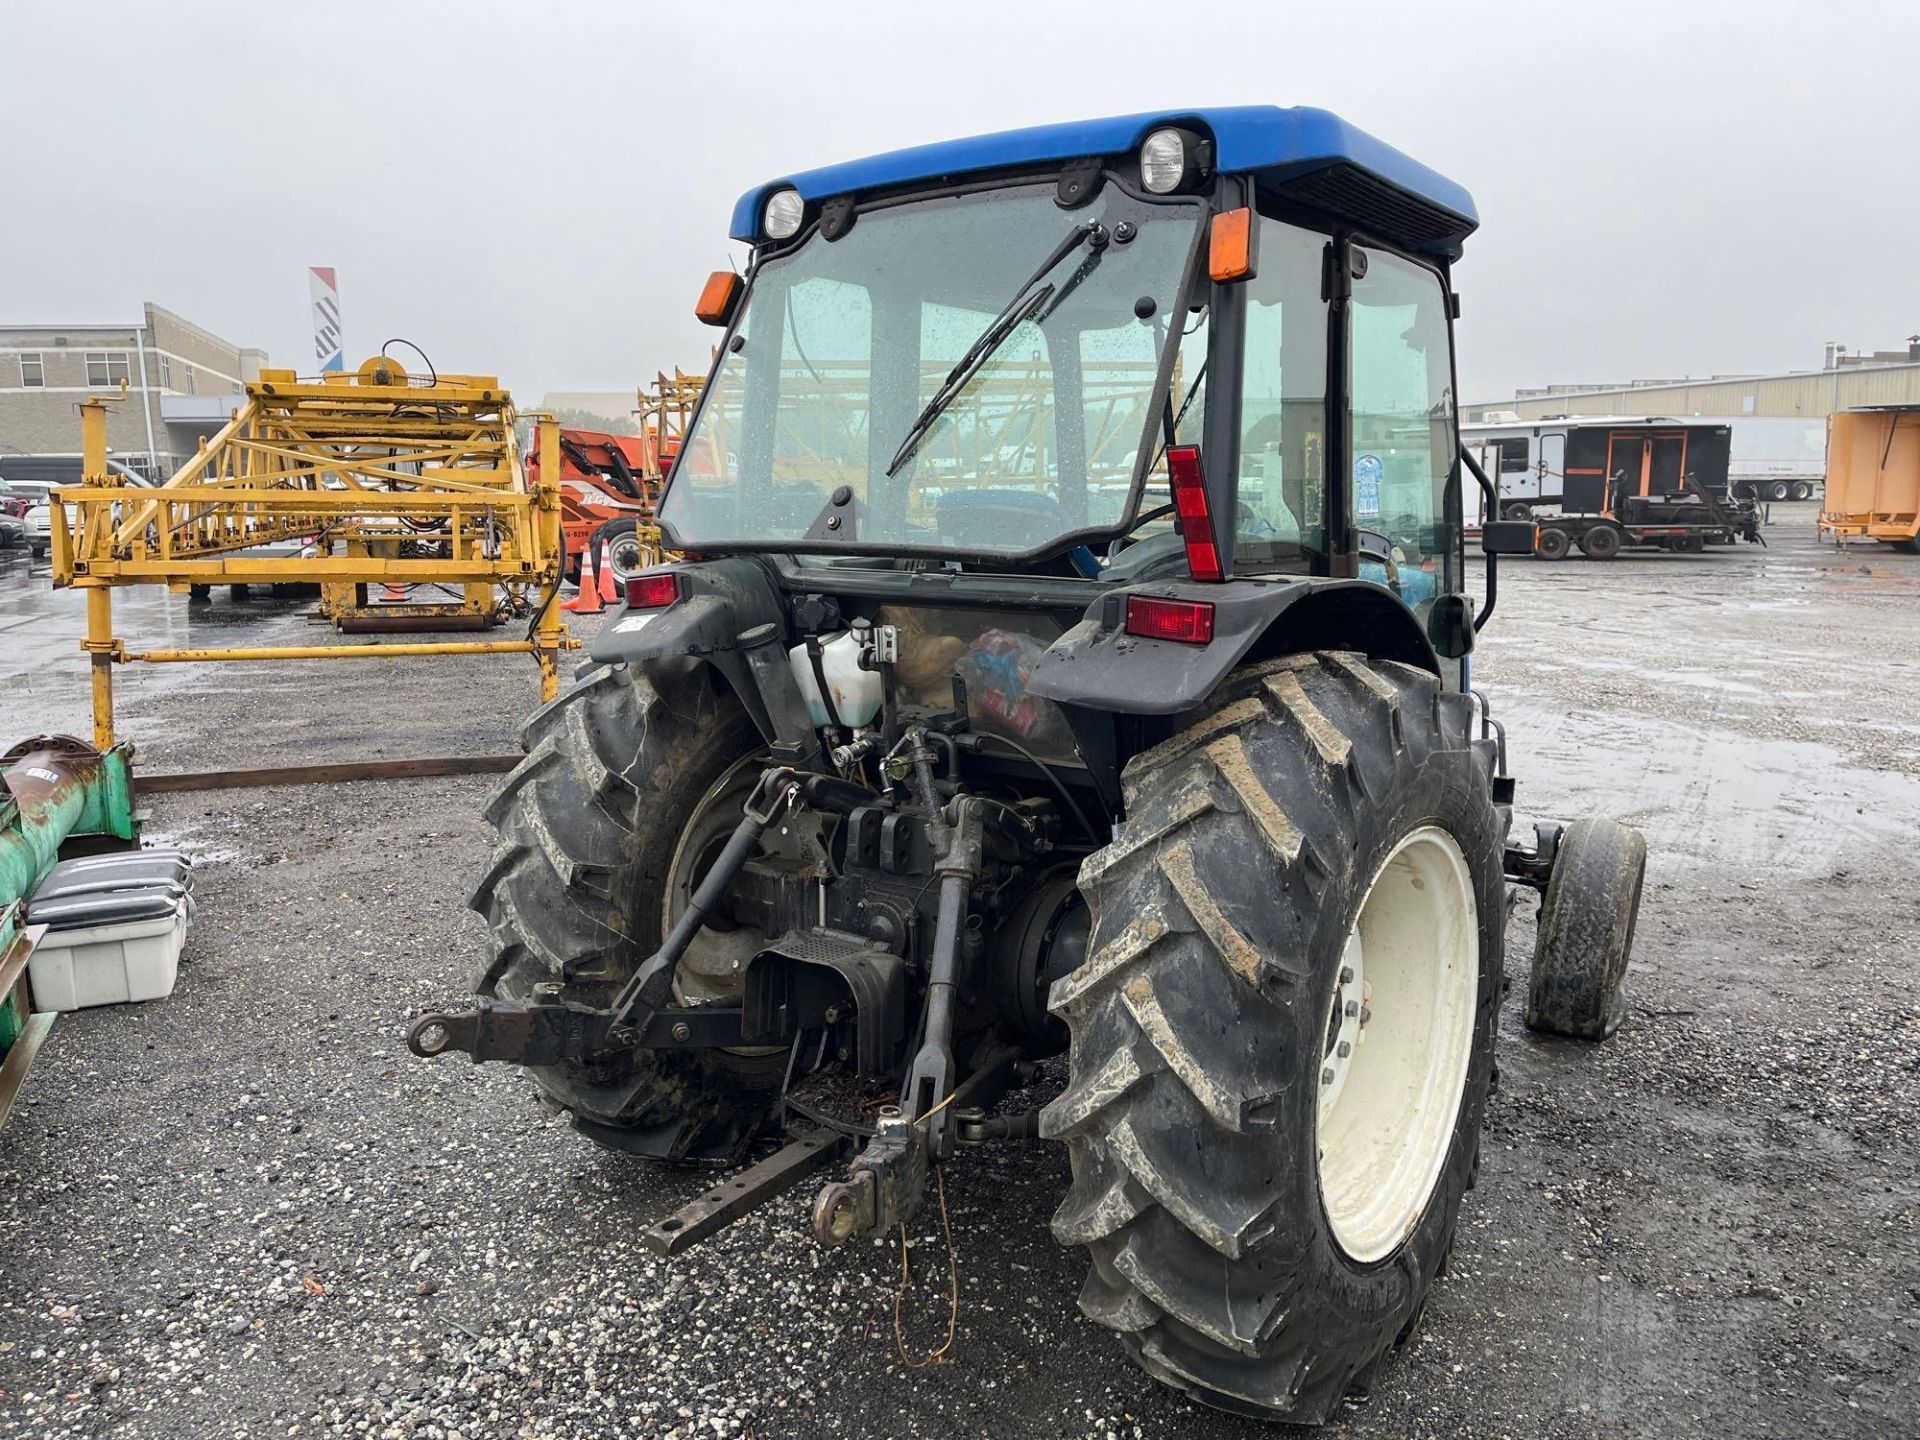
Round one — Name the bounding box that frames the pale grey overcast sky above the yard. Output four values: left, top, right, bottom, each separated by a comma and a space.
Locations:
0, 0, 1920, 403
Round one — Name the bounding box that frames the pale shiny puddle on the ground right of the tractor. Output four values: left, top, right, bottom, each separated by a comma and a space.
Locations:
1492, 687, 1920, 883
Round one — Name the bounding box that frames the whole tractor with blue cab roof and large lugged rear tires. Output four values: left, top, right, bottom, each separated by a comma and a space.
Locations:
409, 108, 1645, 1423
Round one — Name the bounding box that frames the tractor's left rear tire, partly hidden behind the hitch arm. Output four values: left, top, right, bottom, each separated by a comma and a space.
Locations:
470, 666, 780, 1162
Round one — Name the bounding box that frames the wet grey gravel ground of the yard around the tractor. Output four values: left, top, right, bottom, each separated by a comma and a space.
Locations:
0, 505, 1920, 1440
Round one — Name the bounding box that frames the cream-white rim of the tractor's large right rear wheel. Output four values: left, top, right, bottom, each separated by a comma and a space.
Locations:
1315, 826, 1480, 1263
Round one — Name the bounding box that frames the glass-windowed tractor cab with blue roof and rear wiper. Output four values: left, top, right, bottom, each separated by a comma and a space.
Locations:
660, 108, 1476, 672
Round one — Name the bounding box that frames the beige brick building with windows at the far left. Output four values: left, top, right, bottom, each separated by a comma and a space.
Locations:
0, 301, 267, 480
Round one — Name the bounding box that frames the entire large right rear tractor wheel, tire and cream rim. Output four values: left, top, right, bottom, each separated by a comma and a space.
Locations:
1041, 653, 1505, 1423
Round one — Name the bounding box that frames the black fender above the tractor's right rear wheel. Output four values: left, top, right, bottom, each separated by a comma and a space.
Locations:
1027, 580, 1440, 714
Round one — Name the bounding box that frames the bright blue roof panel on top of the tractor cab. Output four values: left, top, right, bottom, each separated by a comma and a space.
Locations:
732, 106, 1480, 257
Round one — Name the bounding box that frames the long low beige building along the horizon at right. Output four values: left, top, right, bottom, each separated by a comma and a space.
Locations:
1461, 336, 1920, 422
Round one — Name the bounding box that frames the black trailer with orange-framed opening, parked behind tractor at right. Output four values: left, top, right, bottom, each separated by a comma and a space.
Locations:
1536, 424, 1766, 561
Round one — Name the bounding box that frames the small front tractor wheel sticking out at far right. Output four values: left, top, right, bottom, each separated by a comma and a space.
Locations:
1524, 820, 1647, 1041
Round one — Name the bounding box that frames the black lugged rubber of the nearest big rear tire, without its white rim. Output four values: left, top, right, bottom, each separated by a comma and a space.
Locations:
1041, 653, 1505, 1423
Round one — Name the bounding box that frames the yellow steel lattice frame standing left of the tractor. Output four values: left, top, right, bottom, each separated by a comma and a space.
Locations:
50, 368, 580, 749
